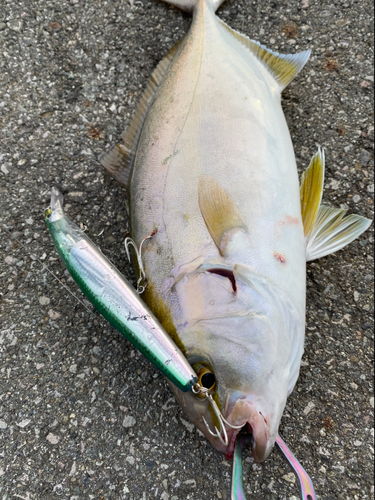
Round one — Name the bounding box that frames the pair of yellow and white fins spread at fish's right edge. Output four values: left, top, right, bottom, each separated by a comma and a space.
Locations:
300, 149, 372, 262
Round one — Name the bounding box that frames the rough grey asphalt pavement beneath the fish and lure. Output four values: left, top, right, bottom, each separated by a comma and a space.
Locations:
0, 0, 374, 500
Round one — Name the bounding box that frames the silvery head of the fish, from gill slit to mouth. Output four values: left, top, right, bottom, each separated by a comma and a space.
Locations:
175, 266, 302, 462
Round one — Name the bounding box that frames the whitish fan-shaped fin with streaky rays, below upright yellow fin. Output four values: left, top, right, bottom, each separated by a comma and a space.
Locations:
306, 205, 372, 262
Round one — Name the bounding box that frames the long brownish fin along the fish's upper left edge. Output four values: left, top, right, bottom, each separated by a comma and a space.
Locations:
99, 37, 184, 187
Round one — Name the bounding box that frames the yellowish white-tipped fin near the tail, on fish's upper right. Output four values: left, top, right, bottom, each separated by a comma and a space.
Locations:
220, 21, 311, 90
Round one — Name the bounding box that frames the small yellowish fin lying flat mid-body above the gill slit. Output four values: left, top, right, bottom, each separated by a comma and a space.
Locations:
198, 175, 246, 255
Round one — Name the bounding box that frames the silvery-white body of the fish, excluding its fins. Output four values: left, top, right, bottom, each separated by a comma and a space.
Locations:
130, 1, 306, 459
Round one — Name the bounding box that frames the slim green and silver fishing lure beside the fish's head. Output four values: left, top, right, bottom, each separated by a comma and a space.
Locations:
45, 188, 197, 392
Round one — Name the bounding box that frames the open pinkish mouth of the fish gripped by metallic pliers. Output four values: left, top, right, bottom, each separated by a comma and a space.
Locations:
225, 400, 270, 462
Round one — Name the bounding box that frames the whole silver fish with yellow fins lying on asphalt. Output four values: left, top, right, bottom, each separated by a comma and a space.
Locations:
100, 0, 371, 462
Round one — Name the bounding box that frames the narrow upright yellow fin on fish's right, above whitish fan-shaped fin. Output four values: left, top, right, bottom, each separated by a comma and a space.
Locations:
300, 148, 325, 237
